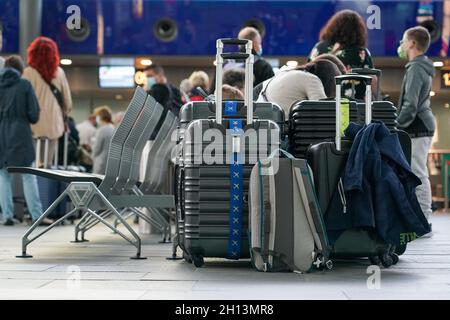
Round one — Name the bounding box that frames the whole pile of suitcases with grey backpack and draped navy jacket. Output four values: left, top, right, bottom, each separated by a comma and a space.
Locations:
171, 39, 428, 272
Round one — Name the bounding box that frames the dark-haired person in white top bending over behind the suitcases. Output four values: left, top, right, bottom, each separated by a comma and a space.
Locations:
257, 60, 341, 117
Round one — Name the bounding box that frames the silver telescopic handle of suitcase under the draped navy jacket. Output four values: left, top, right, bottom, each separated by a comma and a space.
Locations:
335, 73, 372, 151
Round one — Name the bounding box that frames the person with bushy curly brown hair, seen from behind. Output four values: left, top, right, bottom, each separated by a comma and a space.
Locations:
309, 10, 373, 72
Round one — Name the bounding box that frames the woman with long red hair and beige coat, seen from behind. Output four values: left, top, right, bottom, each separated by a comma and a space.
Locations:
23, 37, 72, 168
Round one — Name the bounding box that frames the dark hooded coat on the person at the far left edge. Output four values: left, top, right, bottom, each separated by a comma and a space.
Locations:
0, 68, 39, 169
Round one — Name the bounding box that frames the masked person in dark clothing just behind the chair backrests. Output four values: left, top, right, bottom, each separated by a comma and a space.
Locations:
144, 64, 183, 116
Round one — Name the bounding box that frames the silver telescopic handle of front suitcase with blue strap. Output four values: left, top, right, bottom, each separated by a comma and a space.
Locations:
215, 38, 254, 124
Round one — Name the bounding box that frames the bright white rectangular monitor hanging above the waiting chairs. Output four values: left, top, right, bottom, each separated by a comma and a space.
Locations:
98, 66, 136, 89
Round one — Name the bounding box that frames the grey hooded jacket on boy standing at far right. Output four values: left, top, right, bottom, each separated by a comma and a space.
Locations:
397, 55, 436, 138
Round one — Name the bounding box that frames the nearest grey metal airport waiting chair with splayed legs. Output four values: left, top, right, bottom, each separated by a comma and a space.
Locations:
8, 88, 174, 259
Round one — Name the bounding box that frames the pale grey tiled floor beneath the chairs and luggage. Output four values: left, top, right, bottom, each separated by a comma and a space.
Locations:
0, 214, 450, 299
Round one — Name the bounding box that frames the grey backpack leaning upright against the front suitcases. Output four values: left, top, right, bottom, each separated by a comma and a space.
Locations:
249, 150, 332, 272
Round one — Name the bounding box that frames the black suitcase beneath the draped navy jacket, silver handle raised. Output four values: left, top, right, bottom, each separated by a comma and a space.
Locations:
307, 74, 405, 267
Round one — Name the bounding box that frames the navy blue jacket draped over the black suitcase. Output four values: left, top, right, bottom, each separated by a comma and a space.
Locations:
325, 122, 430, 245
